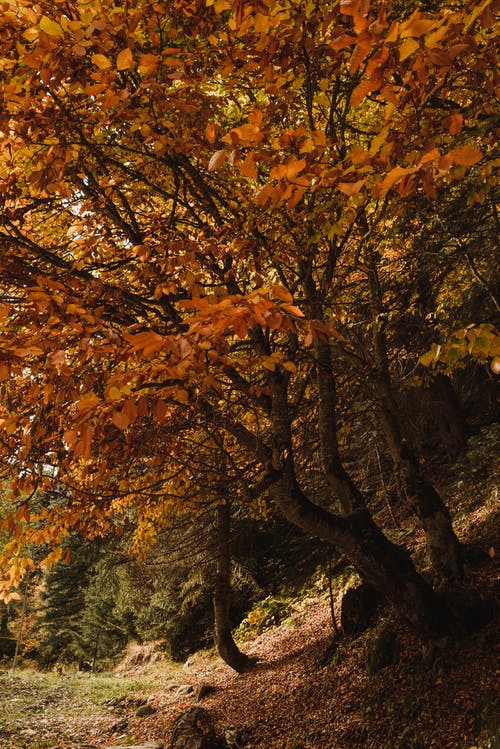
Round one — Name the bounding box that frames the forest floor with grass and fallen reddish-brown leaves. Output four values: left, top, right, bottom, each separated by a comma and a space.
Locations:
0, 462, 500, 749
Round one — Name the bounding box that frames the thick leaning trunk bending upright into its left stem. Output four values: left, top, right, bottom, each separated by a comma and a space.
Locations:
270, 372, 450, 640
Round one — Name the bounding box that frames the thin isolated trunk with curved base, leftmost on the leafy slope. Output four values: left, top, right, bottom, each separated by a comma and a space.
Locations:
213, 502, 251, 674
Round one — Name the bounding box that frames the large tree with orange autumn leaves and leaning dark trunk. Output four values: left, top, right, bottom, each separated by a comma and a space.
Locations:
0, 0, 495, 637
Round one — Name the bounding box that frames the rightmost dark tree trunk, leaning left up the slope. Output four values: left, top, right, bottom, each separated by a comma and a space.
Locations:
369, 252, 463, 584
